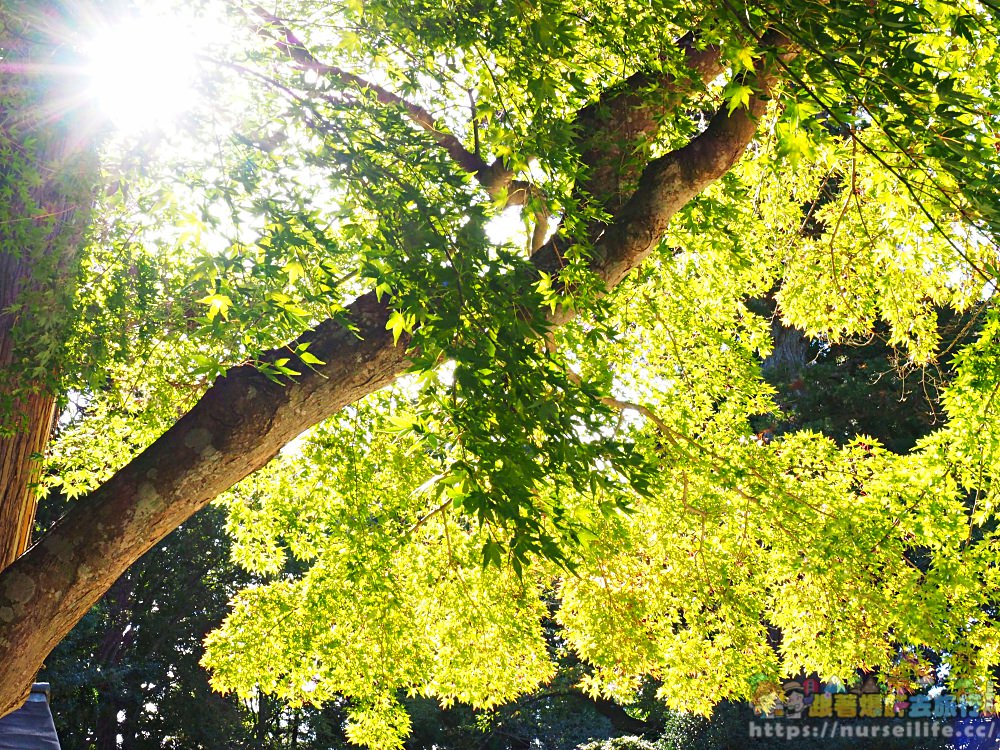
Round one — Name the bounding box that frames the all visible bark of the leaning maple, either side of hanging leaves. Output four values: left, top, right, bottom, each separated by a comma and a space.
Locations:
0, 8, 792, 715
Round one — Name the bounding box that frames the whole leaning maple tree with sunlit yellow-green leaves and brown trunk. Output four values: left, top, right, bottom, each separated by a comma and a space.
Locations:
0, 0, 1000, 745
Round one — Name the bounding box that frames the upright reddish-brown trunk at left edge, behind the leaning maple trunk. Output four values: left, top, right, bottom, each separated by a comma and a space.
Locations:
0, 0, 97, 570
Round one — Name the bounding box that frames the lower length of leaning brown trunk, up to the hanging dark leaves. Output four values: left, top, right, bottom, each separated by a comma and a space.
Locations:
0, 294, 406, 715
